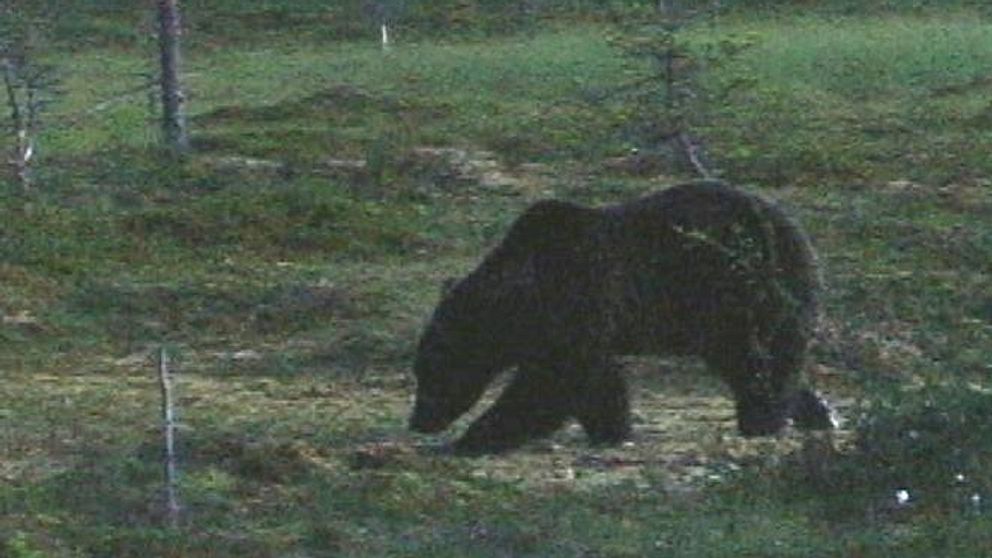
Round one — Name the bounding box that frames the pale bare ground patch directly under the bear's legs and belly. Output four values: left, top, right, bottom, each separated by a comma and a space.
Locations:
442, 392, 849, 492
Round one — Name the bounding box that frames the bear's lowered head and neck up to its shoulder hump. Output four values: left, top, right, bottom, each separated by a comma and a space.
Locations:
410, 201, 598, 433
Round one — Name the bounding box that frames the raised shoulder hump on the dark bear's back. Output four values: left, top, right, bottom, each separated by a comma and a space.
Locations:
504, 200, 601, 249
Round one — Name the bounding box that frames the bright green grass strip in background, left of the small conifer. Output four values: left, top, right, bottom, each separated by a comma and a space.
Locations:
49, 28, 623, 164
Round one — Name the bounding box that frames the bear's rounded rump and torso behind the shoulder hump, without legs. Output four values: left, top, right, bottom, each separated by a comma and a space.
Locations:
602, 181, 819, 352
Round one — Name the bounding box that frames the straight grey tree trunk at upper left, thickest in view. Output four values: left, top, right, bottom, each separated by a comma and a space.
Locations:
158, 0, 189, 154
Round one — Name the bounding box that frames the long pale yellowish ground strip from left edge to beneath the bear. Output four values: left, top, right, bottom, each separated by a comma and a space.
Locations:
0, 354, 853, 498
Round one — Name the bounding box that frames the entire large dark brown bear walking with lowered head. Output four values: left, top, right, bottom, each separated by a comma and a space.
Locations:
410, 181, 829, 454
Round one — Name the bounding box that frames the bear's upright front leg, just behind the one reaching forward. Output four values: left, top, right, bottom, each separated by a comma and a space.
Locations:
573, 360, 630, 446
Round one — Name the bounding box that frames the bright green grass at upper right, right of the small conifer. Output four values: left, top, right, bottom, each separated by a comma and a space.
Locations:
692, 12, 992, 183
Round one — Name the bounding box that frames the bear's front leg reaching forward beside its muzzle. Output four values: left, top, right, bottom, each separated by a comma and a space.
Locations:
454, 365, 571, 456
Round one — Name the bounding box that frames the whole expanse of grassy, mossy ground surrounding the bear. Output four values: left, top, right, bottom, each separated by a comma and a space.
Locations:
0, 3, 992, 557
